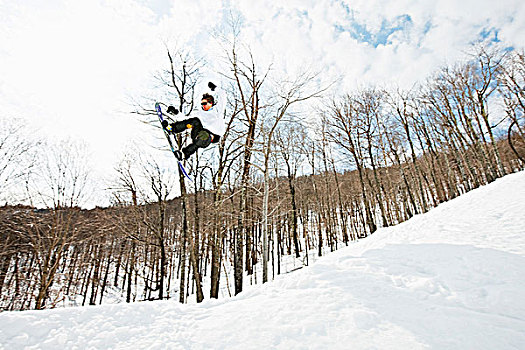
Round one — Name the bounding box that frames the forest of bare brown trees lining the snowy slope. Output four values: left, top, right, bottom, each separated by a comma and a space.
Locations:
0, 41, 525, 310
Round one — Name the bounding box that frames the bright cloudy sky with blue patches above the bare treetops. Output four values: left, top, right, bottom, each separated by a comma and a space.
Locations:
0, 0, 525, 205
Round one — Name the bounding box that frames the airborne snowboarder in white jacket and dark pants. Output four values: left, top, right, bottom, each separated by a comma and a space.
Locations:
162, 82, 226, 160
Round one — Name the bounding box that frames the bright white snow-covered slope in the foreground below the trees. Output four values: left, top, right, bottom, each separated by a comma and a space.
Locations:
0, 172, 525, 350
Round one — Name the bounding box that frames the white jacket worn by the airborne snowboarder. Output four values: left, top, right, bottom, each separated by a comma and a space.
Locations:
190, 87, 226, 136
